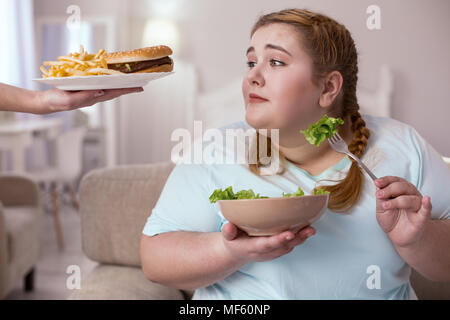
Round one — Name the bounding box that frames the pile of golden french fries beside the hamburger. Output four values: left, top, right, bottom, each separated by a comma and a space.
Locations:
40, 45, 123, 78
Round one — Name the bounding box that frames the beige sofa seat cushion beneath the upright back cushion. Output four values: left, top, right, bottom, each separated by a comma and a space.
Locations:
69, 264, 184, 300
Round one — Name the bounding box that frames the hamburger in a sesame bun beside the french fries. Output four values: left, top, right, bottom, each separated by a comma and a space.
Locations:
104, 46, 173, 73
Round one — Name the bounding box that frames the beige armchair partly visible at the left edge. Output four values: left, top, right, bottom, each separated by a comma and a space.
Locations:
0, 174, 44, 299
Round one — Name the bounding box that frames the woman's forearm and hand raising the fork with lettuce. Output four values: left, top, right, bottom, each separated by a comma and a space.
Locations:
375, 176, 450, 281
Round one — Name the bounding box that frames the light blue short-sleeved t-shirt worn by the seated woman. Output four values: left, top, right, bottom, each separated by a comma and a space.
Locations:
143, 115, 450, 299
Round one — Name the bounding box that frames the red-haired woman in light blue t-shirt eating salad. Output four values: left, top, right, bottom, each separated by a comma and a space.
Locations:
141, 9, 450, 299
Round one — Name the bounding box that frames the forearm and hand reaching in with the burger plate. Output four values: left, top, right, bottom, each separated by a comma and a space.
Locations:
0, 83, 143, 114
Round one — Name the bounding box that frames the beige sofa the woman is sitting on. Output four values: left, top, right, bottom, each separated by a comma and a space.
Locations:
69, 162, 450, 300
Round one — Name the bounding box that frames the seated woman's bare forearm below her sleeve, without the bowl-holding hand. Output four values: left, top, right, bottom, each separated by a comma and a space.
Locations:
141, 231, 244, 290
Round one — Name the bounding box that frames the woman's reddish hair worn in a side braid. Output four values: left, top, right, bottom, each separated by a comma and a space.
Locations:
249, 9, 370, 213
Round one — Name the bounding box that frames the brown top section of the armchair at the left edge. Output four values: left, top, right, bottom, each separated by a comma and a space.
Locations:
0, 175, 40, 207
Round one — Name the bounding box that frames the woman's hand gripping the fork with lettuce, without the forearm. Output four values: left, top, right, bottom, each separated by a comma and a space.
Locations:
375, 176, 432, 247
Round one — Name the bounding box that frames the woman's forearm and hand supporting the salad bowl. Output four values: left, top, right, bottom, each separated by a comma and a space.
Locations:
140, 223, 315, 290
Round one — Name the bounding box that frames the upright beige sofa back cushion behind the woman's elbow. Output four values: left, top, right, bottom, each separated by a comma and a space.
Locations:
80, 162, 174, 267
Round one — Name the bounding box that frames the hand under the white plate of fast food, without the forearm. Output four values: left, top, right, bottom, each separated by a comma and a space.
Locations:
33, 87, 144, 114
